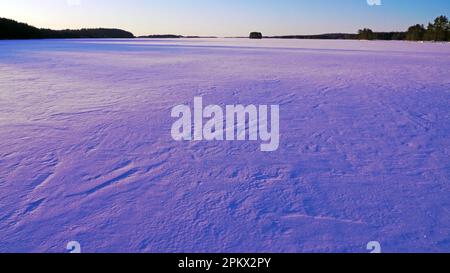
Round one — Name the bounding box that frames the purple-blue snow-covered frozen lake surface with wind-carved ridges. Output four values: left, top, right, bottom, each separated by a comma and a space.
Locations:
0, 39, 450, 252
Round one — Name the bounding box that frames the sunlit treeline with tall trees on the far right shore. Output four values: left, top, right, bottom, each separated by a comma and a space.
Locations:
357, 16, 450, 41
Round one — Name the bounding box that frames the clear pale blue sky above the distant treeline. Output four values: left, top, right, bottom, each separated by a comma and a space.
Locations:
0, 0, 450, 36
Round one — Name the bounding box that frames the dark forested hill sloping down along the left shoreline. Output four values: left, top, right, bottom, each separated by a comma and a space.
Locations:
0, 18, 134, 39
